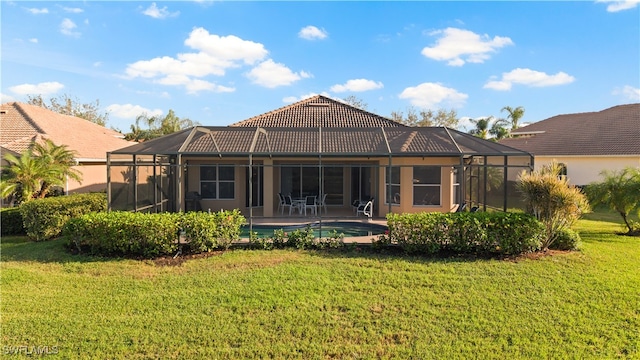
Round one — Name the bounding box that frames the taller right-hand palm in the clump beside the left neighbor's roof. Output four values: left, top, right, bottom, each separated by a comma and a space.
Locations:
31, 139, 82, 198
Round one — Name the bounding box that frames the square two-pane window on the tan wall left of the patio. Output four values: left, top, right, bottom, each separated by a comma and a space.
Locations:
200, 165, 235, 200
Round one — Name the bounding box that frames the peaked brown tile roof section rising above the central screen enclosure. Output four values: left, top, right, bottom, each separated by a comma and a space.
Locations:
230, 95, 405, 128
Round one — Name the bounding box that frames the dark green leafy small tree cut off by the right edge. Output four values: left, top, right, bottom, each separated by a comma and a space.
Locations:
586, 167, 640, 235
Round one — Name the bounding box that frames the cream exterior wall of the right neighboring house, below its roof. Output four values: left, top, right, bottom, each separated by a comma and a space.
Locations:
535, 155, 640, 186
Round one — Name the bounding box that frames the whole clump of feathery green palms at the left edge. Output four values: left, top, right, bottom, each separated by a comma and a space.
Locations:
0, 139, 82, 203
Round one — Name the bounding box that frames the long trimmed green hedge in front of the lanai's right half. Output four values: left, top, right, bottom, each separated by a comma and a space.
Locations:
381, 212, 544, 255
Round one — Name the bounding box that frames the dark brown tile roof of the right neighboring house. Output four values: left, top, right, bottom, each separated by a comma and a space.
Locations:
500, 103, 640, 156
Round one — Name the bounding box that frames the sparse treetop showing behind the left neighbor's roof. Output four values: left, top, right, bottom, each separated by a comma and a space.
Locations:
27, 94, 109, 126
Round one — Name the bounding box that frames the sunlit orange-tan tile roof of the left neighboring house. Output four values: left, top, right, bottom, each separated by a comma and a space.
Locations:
0, 102, 135, 160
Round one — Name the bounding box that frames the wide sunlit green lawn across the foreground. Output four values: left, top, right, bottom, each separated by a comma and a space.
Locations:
0, 214, 640, 359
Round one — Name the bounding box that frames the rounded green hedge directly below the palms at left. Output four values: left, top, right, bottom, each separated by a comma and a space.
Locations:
20, 193, 107, 241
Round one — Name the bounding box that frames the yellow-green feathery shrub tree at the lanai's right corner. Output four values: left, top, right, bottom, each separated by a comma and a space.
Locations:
516, 162, 590, 249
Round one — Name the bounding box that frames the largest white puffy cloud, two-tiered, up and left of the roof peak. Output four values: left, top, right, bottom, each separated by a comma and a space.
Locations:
125, 28, 268, 93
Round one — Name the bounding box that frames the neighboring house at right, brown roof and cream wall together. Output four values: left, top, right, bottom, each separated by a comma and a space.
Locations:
500, 104, 640, 186
